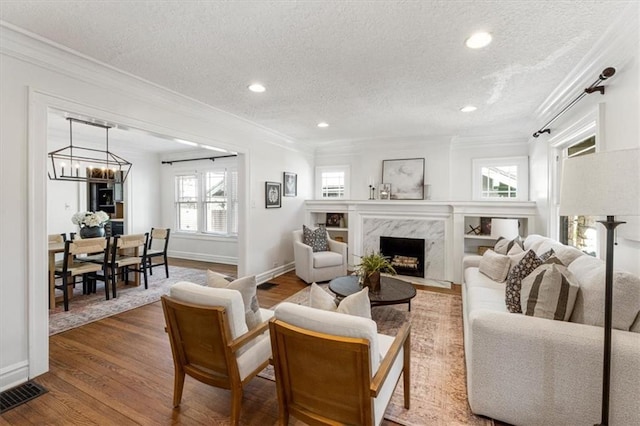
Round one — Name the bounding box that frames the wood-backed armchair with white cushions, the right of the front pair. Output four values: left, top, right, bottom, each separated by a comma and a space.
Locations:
269, 302, 411, 425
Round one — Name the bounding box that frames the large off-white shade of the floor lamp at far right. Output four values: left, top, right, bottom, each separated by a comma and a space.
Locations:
560, 149, 640, 216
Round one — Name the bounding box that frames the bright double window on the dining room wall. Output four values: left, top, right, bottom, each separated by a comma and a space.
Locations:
175, 170, 238, 235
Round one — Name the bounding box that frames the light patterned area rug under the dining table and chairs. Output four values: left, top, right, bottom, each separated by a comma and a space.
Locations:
49, 266, 207, 336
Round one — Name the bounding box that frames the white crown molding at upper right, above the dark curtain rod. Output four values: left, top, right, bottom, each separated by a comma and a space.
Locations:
534, 1, 640, 124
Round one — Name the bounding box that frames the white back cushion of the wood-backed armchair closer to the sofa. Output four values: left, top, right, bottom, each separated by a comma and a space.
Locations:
275, 302, 380, 377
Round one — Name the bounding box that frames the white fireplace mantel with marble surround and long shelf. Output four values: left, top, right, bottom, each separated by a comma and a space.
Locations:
305, 200, 536, 283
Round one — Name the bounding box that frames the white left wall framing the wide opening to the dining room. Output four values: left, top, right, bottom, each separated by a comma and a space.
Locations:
0, 26, 312, 389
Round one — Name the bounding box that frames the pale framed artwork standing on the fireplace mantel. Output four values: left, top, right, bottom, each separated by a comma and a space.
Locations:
382, 158, 424, 200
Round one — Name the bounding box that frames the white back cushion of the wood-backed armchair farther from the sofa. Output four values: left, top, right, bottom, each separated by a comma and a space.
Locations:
169, 281, 249, 339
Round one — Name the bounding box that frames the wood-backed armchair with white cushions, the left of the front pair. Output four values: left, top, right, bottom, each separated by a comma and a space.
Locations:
162, 282, 273, 425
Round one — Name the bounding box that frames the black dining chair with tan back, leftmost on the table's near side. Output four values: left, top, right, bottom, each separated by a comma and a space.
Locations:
54, 237, 109, 311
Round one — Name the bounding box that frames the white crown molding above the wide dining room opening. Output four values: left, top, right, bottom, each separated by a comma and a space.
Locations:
0, 21, 313, 154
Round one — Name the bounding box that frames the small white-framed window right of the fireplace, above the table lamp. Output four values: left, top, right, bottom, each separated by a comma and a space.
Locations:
473, 157, 529, 201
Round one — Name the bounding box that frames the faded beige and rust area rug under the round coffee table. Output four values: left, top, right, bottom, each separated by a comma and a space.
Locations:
260, 285, 493, 426
